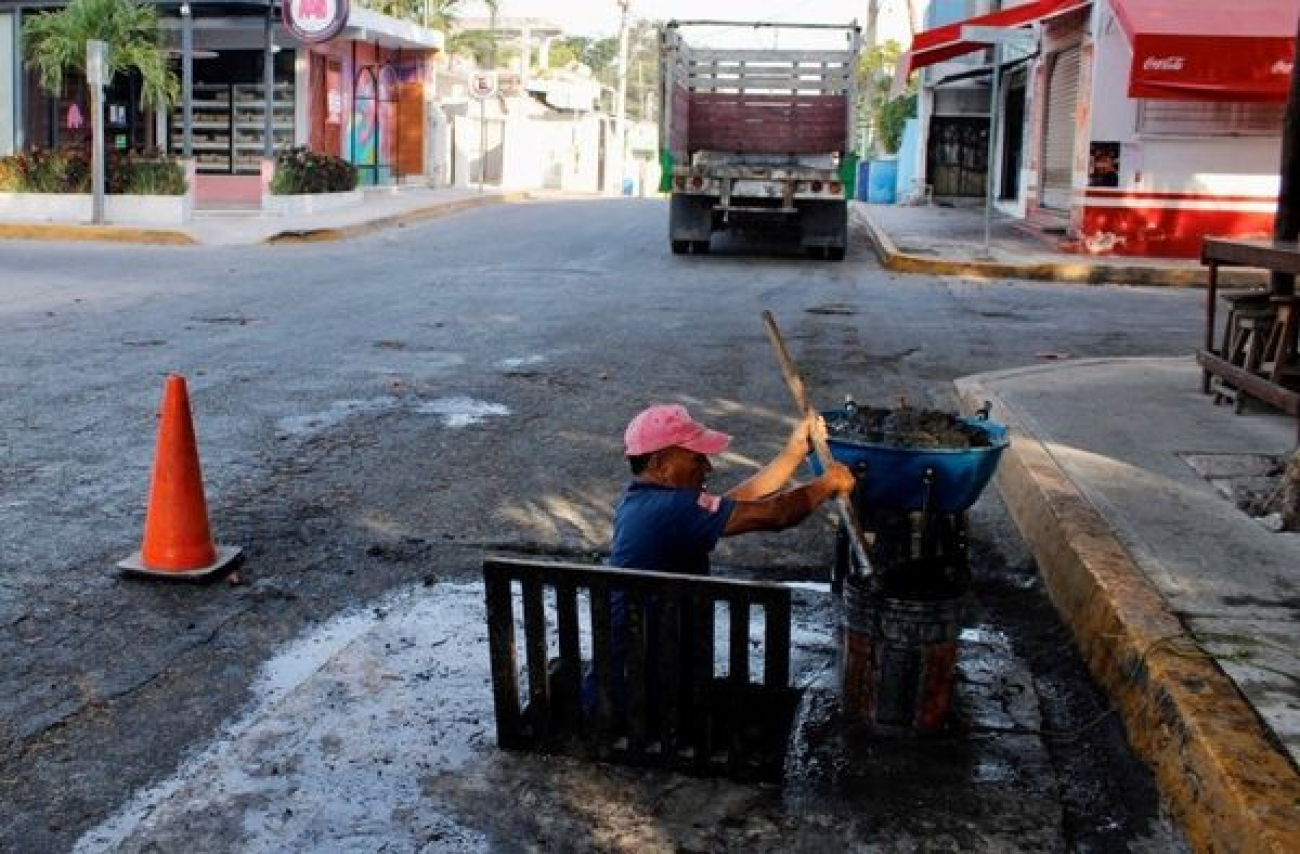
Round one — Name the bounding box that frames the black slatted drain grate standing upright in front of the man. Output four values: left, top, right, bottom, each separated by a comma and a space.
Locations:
484, 556, 798, 780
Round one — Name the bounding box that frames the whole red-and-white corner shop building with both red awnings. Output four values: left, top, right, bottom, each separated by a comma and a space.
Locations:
907, 0, 1300, 257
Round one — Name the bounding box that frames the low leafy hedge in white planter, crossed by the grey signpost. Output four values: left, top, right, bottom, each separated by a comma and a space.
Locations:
0, 146, 186, 195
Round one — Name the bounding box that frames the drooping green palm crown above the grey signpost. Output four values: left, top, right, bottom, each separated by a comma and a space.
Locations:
23, 0, 179, 109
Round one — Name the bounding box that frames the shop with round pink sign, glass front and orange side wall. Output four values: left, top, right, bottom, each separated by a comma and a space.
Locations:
0, 0, 443, 207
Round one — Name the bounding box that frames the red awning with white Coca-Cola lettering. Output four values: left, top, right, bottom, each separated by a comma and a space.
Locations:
1110, 0, 1300, 101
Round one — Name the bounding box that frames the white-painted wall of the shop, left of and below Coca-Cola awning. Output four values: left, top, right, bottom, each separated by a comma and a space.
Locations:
1089, 3, 1282, 195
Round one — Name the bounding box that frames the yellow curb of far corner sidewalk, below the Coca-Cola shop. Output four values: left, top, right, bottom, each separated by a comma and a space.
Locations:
850, 207, 1265, 287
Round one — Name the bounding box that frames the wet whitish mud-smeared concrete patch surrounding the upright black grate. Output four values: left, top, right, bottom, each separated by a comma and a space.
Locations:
77, 582, 1092, 851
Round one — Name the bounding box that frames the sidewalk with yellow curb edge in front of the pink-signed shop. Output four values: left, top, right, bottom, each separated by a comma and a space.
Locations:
0, 187, 534, 246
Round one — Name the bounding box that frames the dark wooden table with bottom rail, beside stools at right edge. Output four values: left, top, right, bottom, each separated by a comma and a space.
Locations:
1196, 238, 1300, 441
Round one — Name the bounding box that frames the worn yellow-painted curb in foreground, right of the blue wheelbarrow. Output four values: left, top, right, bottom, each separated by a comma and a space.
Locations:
957, 369, 1300, 854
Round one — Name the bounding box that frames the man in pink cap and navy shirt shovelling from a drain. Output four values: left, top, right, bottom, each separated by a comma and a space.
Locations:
582, 404, 854, 716
